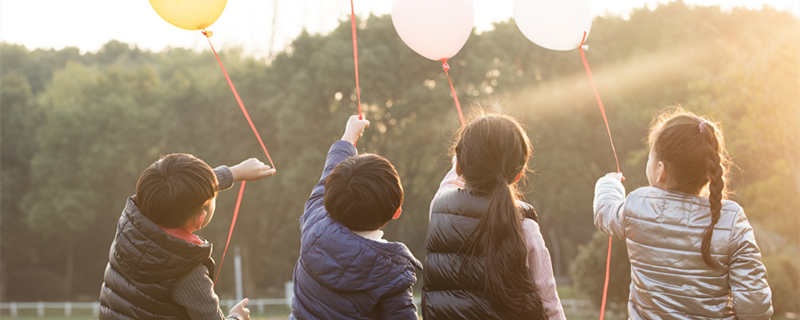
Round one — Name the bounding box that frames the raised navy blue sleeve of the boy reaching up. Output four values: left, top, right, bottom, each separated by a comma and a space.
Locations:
300, 140, 358, 232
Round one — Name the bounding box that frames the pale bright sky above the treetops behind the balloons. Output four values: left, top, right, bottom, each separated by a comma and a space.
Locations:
0, 0, 800, 57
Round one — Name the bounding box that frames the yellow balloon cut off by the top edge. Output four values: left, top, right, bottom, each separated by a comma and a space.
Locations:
150, 0, 228, 30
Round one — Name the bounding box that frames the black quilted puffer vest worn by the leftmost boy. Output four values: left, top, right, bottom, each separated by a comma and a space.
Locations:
100, 198, 214, 319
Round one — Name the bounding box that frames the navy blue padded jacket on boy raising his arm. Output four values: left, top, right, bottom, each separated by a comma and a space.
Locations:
292, 141, 422, 320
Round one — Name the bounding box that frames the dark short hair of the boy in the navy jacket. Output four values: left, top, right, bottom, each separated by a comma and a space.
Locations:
325, 154, 403, 231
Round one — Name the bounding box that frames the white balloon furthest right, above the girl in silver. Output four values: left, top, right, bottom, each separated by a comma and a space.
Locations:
514, 0, 592, 51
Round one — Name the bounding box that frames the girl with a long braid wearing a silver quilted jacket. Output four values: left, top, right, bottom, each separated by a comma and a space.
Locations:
594, 110, 772, 319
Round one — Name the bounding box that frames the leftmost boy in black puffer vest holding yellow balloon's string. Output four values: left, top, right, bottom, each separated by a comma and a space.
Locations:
100, 153, 275, 320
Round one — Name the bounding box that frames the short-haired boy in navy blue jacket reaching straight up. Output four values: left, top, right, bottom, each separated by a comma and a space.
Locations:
291, 116, 421, 320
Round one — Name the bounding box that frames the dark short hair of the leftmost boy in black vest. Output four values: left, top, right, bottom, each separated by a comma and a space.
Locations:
135, 153, 218, 228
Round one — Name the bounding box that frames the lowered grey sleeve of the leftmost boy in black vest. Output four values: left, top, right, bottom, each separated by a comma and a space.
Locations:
172, 265, 244, 320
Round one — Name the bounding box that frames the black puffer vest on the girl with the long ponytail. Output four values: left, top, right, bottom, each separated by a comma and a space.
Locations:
422, 189, 538, 320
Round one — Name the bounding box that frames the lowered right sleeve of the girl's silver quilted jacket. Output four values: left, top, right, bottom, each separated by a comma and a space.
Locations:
728, 211, 773, 319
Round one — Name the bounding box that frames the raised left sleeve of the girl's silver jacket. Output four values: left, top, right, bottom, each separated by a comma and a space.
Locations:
592, 175, 625, 238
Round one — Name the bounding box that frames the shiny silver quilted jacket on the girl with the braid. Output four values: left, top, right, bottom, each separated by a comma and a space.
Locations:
594, 176, 772, 319
